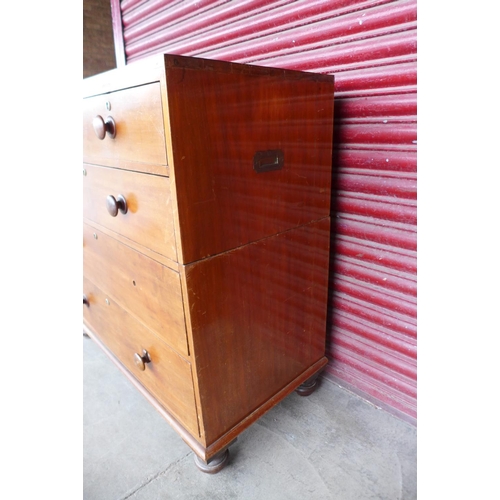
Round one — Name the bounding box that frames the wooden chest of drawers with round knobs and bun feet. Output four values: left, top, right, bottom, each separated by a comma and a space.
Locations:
83, 55, 333, 472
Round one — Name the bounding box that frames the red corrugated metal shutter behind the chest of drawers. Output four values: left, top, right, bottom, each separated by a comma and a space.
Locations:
114, 0, 417, 420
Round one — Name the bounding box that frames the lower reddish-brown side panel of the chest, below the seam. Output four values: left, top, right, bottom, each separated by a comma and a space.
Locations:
185, 218, 330, 443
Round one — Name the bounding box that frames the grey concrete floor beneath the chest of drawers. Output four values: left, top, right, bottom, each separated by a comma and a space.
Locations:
83, 337, 417, 500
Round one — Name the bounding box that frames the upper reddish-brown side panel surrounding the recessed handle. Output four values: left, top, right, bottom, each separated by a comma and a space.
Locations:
167, 58, 333, 264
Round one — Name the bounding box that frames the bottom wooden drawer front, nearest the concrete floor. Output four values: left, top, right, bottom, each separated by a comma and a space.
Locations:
83, 278, 199, 436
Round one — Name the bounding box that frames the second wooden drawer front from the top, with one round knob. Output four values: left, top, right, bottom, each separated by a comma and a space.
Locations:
83, 165, 177, 261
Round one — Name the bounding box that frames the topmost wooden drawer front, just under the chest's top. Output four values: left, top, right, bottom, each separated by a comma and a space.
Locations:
83, 83, 167, 175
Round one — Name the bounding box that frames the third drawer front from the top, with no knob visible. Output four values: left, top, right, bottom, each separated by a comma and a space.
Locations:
83, 224, 189, 355
